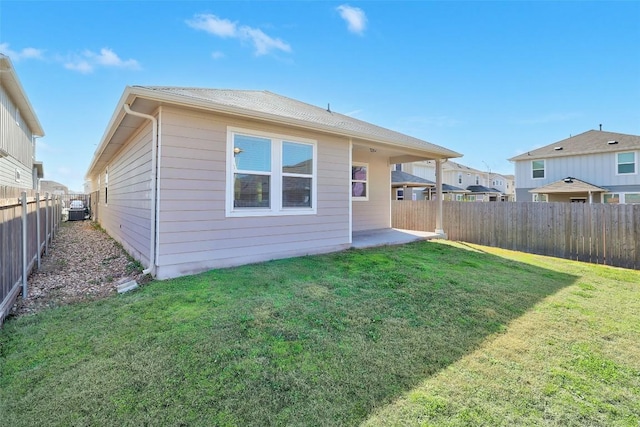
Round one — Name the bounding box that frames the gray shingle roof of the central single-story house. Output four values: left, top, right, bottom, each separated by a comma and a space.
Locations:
133, 86, 461, 158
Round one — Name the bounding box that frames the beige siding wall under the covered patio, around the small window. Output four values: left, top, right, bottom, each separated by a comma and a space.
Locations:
353, 150, 391, 231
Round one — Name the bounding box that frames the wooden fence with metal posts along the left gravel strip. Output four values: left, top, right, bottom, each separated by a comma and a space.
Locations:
0, 190, 61, 325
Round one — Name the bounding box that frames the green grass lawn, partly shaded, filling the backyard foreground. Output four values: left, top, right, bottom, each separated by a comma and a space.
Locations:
0, 242, 640, 426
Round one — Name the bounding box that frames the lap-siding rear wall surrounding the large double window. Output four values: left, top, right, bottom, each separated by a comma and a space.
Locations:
157, 108, 350, 278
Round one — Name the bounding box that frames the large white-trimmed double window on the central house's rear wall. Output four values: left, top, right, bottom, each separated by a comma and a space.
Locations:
227, 128, 317, 216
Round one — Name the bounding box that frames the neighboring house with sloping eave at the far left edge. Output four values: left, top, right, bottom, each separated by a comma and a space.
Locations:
0, 53, 44, 190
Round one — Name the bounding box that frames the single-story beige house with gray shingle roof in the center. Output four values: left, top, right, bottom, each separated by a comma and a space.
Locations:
87, 86, 460, 279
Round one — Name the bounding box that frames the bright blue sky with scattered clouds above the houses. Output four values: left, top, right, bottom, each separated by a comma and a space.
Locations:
0, 0, 640, 190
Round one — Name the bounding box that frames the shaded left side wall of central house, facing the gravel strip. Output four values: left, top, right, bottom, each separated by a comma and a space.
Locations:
91, 120, 152, 267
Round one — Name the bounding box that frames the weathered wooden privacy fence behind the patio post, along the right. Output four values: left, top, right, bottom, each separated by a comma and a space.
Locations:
391, 201, 640, 269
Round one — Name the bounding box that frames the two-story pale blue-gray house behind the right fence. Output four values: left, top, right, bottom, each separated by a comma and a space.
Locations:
509, 130, 640, 203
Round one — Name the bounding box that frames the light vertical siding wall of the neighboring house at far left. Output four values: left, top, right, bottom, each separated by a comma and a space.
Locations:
0, 86, 34, 188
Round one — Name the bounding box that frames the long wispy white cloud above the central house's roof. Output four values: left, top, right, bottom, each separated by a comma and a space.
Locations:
186, 14, 291, 56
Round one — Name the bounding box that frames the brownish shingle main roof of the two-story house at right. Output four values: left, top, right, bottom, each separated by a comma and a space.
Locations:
509, 130, 640, 162
